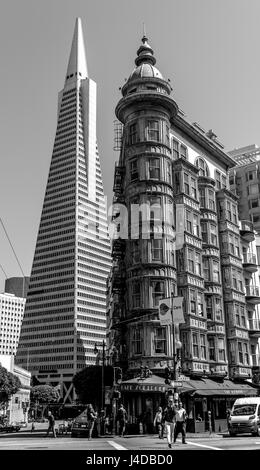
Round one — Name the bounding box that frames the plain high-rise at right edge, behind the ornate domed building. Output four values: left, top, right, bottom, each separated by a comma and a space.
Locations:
229, 145, 260, 234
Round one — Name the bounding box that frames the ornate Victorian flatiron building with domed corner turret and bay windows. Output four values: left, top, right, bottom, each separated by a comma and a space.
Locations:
107, 32, 260, 430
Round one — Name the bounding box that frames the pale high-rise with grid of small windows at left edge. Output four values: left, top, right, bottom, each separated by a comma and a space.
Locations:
0, 292, 26, 355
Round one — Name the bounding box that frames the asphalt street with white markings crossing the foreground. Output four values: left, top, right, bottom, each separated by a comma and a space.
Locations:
0, 429, 260, 453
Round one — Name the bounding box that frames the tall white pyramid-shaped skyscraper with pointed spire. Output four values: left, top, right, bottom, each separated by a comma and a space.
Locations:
16, 18, 111, 402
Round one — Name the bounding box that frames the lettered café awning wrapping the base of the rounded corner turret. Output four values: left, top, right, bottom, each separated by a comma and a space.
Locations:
121, 375, 194, 393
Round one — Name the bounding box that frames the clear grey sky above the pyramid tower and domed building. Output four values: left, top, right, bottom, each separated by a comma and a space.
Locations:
0, 0, 260, 292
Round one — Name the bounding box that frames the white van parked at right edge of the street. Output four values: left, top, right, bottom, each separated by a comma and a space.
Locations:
229, 397, 260, 436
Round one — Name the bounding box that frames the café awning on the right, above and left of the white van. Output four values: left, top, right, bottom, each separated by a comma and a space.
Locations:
186, 379, 257, 397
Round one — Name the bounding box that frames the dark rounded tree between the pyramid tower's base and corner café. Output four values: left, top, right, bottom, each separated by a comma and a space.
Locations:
72, 366, 113, 408
